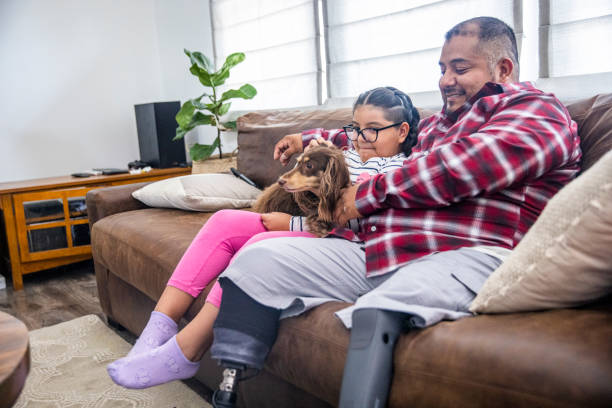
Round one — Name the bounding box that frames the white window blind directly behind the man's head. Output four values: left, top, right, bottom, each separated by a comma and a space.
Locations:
324, 0, 522, 98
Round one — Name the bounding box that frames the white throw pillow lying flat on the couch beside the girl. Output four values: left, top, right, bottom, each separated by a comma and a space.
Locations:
132, 173, 261, 211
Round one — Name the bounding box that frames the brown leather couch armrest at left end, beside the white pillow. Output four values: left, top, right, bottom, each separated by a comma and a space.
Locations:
86, 182, 150, 229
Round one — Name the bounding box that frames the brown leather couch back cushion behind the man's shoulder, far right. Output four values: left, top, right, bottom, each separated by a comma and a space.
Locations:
567, 94, 612, 171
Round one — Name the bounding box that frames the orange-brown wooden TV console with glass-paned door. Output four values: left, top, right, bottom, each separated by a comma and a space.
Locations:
0, 167, 191, 290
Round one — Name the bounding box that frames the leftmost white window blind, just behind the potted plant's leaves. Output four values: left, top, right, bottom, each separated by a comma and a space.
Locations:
211, 0, 321, 110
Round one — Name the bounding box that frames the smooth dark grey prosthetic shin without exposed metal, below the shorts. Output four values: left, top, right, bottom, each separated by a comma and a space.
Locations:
339, 309, 403, 408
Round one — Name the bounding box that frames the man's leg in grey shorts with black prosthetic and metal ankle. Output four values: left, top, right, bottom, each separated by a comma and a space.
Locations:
211, 238, 382, 407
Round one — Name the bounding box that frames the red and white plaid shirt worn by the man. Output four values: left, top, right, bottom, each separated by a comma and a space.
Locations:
303, 83, 581, 276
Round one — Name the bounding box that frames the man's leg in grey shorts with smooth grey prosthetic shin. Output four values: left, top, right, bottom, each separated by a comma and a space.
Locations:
337, 248, 501, 408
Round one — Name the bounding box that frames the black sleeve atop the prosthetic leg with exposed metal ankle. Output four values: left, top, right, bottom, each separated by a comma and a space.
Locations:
213, 278, 280, 348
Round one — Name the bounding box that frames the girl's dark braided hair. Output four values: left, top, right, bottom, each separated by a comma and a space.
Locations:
353, 86, 420, 156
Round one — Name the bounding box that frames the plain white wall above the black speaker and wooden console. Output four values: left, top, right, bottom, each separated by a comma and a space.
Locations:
0, 0, 212, 182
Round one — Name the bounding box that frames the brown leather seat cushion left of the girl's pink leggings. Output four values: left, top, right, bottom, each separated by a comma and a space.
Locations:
91, 208, 212, 300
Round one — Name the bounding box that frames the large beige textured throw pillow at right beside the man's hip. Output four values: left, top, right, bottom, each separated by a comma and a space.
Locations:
470, 151, 612, 313
